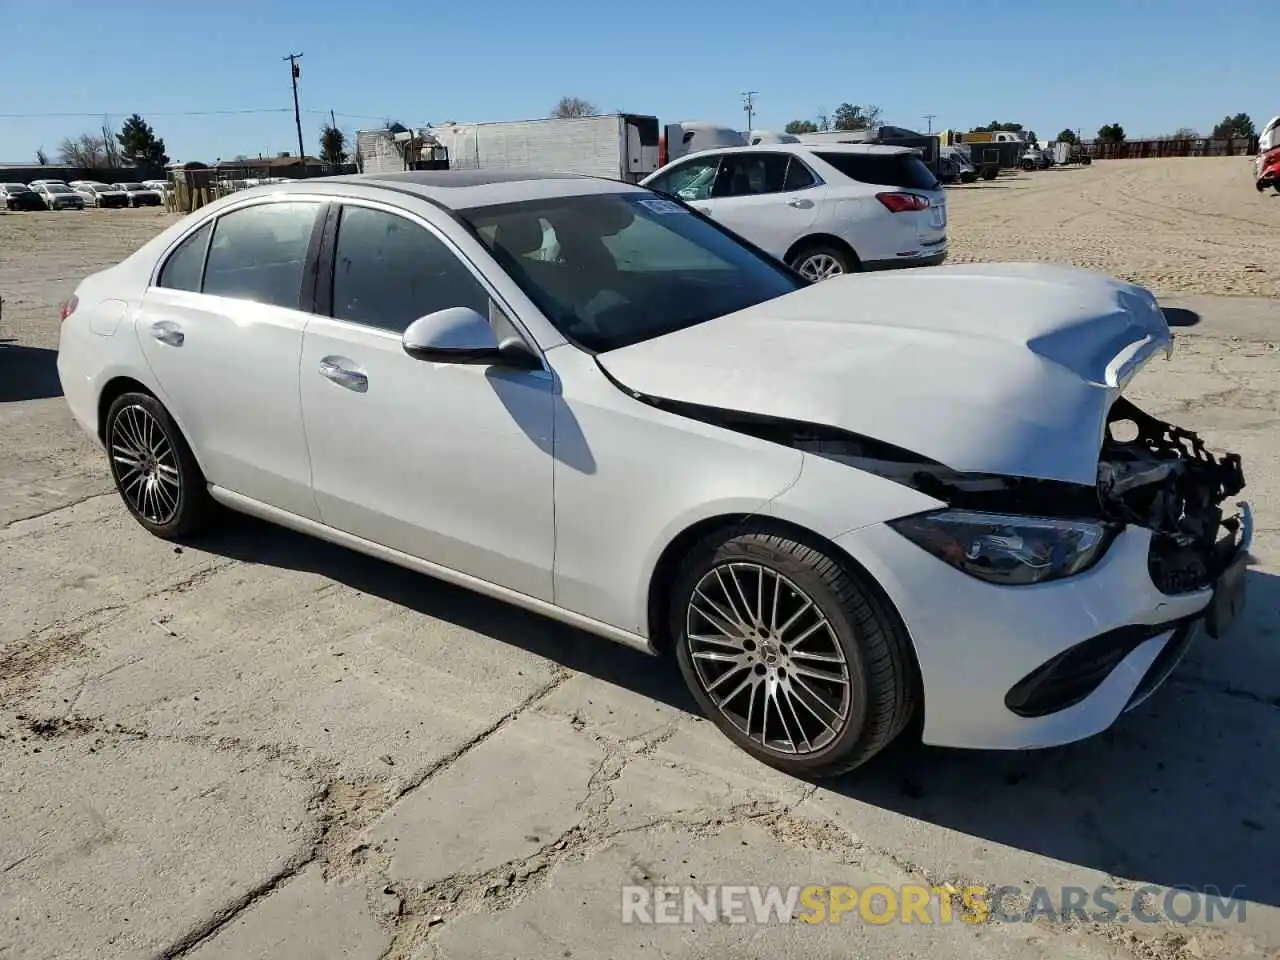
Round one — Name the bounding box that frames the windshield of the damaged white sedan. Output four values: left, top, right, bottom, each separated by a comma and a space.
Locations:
458, 192, 804, 352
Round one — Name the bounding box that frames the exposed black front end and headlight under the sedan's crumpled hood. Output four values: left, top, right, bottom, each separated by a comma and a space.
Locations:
632, 394, 1252, 627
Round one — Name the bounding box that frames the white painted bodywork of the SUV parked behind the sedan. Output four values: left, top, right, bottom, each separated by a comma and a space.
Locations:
641, 143, 947, 276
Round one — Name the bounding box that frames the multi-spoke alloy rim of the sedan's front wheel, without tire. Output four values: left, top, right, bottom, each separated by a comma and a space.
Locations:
685, 563, 850, 754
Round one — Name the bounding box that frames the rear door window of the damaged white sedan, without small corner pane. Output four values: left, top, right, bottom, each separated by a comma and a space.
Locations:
204, 201, 320, 310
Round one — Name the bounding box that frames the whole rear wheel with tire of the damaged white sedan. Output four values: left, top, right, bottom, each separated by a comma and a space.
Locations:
102, 393, 212, 540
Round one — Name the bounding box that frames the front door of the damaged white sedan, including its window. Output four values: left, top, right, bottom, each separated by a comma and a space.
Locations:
302, 201, 556, 600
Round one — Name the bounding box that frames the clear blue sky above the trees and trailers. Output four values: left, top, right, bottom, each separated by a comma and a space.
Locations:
0, 0, 1280, 163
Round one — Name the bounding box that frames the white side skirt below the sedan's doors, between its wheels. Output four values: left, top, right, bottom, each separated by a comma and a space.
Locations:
209, 484, 657, 655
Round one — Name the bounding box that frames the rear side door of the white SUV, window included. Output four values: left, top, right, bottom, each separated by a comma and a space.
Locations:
695, 151, 822, 259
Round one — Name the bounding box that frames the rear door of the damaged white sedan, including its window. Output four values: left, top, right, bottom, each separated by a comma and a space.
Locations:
136, 197, 325, 518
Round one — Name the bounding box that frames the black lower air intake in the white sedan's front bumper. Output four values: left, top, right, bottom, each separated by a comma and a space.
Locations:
1005, 623, 1174, 718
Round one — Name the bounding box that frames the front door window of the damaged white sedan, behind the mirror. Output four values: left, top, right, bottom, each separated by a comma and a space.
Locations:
333, 206, 488, 333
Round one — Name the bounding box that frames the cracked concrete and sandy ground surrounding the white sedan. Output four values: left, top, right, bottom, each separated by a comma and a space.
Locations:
0, 161, 1280, 960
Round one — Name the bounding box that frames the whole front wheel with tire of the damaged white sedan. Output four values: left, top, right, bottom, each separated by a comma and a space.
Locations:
669, 525, 916, 777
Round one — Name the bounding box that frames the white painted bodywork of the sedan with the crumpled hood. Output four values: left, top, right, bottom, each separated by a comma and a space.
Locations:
58, 173, 1248, 773
